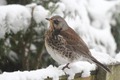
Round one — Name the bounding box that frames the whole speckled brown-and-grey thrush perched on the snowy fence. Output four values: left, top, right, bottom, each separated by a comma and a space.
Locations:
45, 15, 111, 72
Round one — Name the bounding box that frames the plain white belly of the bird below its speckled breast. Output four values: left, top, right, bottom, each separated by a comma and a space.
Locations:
45, 42, 70, 64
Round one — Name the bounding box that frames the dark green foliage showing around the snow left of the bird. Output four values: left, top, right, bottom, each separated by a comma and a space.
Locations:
0, 0, 60, 71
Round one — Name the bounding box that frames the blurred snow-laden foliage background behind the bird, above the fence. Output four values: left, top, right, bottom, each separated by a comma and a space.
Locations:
0, 0, 120, 73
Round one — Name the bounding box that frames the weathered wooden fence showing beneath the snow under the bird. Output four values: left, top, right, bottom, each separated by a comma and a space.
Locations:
45, 64, 120, 80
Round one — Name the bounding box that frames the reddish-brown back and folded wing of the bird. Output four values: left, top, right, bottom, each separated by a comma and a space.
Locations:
60, 28, 91, 57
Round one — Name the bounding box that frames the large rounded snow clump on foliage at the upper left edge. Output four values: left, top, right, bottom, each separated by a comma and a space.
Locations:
0, 5, 31, 38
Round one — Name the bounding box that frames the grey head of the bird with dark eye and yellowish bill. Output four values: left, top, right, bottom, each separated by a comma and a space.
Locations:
46, 16, 68, 30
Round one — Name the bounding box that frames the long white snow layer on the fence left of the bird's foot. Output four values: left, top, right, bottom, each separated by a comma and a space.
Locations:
0, 65, 64, 80
